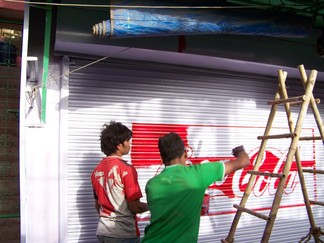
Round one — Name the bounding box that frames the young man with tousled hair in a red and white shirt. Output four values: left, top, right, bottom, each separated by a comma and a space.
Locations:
91, 121, 148, 243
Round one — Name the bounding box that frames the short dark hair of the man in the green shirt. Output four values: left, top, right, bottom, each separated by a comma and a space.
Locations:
159, 132, 184, 165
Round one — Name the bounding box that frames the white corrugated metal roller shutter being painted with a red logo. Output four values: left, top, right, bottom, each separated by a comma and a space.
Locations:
66, 58, 324, 243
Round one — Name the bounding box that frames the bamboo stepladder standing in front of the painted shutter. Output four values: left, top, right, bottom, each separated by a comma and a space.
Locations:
221, 65, 324, 243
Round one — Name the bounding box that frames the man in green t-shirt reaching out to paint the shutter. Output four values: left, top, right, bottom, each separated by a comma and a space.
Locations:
141, 133, 250, 243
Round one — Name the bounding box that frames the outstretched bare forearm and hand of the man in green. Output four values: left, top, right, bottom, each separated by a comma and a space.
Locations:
224, 146, 250, 175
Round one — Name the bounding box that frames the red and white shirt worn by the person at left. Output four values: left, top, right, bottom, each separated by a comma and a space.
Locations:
91, 156, 142, 238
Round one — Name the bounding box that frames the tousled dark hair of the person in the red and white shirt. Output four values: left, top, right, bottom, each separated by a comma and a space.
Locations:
100, 121, 133, 156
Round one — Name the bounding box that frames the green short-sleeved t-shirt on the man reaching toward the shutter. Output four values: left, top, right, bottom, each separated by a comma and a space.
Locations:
141, 162, 225, 243
